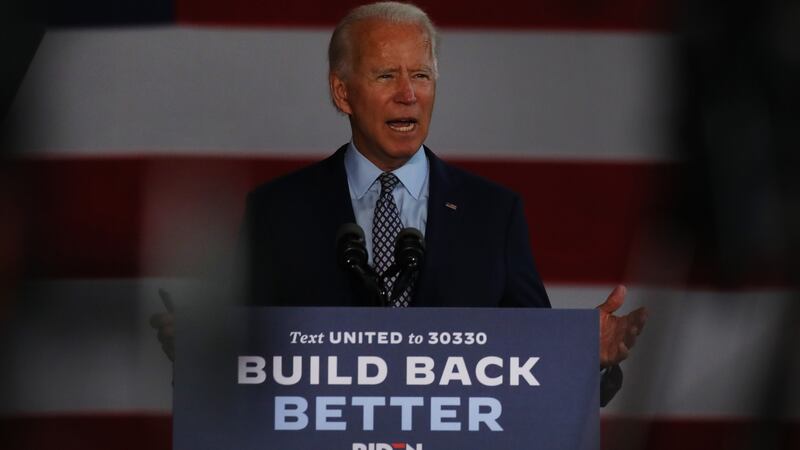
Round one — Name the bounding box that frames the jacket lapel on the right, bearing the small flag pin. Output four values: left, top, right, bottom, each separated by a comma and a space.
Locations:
413, 147, 465, 306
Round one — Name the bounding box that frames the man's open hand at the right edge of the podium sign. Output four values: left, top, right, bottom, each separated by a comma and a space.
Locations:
597, 285, 647, 367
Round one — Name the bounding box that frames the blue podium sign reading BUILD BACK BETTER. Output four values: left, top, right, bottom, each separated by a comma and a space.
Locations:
173, 308, 599, 450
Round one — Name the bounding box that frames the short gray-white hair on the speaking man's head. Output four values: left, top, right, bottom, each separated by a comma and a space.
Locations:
328, 2, 439, 78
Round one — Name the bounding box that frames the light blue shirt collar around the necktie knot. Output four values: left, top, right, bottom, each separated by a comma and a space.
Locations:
344, 141, 428, 200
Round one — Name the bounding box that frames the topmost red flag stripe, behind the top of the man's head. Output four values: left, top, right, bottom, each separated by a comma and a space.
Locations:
176, 0, 671, 30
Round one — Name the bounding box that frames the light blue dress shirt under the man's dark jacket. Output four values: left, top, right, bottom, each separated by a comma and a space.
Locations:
344, 142, 428, 265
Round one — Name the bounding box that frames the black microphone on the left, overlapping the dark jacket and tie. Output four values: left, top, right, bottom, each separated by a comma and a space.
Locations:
336, 223, 383, 305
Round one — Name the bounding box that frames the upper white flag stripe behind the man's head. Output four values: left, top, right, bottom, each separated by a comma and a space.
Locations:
11, 27, 672, 161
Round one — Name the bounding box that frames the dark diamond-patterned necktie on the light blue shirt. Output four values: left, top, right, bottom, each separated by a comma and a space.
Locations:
372, 172, 410, 307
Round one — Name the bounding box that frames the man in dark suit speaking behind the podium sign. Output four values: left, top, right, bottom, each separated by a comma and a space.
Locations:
152, 2, 646, 404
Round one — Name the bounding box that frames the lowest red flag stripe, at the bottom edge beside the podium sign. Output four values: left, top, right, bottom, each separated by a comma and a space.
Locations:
0, 413, 800, 450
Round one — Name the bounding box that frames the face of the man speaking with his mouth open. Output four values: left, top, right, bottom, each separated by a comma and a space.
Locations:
330, 20, 436, 170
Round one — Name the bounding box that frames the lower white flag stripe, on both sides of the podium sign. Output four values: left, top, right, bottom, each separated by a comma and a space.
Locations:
0, 278, 800, 419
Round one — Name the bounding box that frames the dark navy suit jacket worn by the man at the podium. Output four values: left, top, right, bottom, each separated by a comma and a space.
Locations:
242, 145, 550, 307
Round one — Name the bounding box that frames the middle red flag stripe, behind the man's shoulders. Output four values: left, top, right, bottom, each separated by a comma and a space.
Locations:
6, 156, 782, 286
